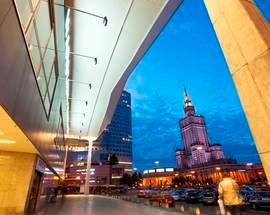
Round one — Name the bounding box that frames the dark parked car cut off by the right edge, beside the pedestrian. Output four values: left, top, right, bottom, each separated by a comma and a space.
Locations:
249, 190, 270, 210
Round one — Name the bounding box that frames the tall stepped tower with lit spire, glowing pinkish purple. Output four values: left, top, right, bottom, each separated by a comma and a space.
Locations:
176, 89, 225, 169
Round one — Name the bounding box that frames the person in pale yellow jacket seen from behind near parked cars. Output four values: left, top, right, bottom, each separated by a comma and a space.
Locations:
218, 170, 243, 215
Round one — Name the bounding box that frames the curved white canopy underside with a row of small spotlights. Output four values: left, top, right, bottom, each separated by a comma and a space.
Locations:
62, 0, 181, 138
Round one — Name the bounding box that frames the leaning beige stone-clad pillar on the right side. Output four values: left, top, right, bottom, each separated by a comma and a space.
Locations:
204, 0, 270, 182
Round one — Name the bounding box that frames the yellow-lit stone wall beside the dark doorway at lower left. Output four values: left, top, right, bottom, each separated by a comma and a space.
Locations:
0, 151, 36, 215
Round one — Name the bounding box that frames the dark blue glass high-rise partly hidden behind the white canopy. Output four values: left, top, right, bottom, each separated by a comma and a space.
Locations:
92, 91, 132, 173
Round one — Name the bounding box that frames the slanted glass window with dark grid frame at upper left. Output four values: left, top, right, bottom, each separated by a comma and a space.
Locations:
14, 0, 58, 117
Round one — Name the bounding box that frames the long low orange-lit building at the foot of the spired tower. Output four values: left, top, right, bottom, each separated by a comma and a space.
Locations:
142, 163, 266, 187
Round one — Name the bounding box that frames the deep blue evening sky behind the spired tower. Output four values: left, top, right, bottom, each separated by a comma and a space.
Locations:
125, 0, 270, 170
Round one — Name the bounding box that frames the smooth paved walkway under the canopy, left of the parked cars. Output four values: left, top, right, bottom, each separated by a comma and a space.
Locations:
38, 195, 179, 215
